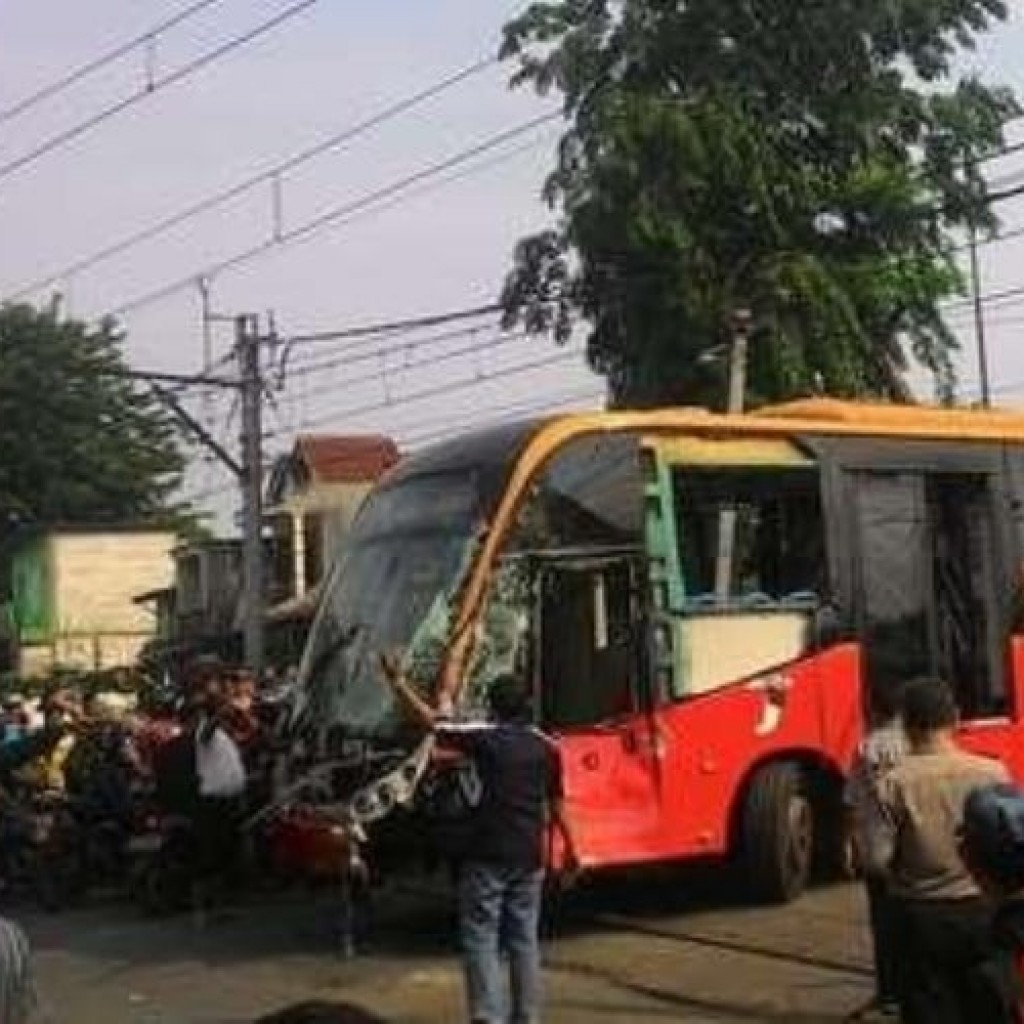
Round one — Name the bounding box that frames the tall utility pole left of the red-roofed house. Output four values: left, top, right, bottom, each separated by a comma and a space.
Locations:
234, 314, 264, 676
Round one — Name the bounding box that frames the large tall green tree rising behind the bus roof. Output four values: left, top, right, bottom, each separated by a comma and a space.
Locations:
503, 0, 1018, 406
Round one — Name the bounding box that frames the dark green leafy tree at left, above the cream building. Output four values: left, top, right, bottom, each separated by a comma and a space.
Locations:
0, 305, 184, 536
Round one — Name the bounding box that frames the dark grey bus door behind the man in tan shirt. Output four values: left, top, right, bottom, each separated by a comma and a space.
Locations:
849, 470, 1024, 772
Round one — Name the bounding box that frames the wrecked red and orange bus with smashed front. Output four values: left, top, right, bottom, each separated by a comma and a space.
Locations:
282, 399, 1024, 899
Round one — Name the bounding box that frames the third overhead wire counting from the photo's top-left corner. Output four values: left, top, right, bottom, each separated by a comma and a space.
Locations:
11, 56, 496, 299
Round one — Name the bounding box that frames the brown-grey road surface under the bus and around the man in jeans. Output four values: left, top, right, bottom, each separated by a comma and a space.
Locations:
15, 872, 870, 1024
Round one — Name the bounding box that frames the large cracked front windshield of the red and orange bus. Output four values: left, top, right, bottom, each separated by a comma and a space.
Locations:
298, 421, 536, 738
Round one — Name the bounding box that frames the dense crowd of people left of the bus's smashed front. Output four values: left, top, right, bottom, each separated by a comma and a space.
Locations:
0, 658, 270, 917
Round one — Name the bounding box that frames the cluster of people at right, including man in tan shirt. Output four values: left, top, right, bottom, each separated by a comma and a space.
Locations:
847, 679, 1024, 1024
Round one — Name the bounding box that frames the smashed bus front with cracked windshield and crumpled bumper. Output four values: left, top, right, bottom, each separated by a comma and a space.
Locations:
275, 425, 548, 873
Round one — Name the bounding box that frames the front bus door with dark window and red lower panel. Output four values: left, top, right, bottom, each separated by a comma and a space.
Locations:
535, 553, 662, 863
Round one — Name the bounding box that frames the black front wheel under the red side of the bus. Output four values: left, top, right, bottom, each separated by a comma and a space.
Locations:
740, 762, 814, 903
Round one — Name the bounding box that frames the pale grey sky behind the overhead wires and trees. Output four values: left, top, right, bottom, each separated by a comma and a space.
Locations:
0, 0, 1024, 517
